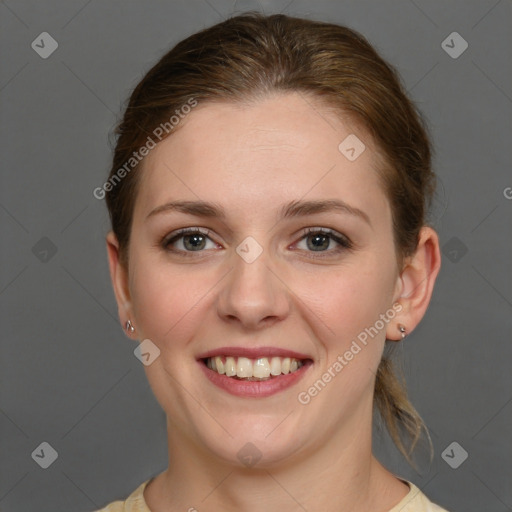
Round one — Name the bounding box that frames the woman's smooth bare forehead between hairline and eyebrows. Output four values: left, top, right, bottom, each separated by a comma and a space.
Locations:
136, 93, 387, 224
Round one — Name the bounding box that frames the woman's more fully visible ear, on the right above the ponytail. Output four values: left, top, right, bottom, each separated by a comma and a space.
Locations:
386, 226, 441, 341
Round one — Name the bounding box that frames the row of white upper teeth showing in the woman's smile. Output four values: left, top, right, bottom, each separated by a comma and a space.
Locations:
206, 356, 304, 380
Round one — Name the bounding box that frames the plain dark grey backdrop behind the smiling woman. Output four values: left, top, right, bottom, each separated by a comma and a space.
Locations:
0, 0, 512, 512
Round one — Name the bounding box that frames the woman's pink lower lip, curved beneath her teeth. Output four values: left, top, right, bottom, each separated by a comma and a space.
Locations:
198, 360, 313, 398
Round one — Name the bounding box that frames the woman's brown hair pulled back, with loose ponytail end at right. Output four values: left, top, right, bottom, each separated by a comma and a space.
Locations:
106, 12, 435, 462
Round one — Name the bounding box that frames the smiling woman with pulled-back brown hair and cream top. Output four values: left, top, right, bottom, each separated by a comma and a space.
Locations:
99, 13, 443, 512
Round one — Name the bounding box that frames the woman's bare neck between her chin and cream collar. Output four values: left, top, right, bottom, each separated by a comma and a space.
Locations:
145, 410, 408, 512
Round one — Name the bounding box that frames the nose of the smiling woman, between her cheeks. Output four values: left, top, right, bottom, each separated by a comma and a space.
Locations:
217, 245, 290, 330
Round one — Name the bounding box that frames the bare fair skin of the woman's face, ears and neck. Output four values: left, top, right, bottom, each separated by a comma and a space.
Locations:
107, 93, 440, 512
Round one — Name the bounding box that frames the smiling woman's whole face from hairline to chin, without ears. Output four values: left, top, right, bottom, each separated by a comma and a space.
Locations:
110, 94, 401, 465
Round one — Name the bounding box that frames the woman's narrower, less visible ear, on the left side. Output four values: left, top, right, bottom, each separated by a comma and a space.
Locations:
106, 231, 135, 339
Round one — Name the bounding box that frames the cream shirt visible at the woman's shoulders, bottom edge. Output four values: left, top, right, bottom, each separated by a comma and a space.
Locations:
95, 480, 448, 512
